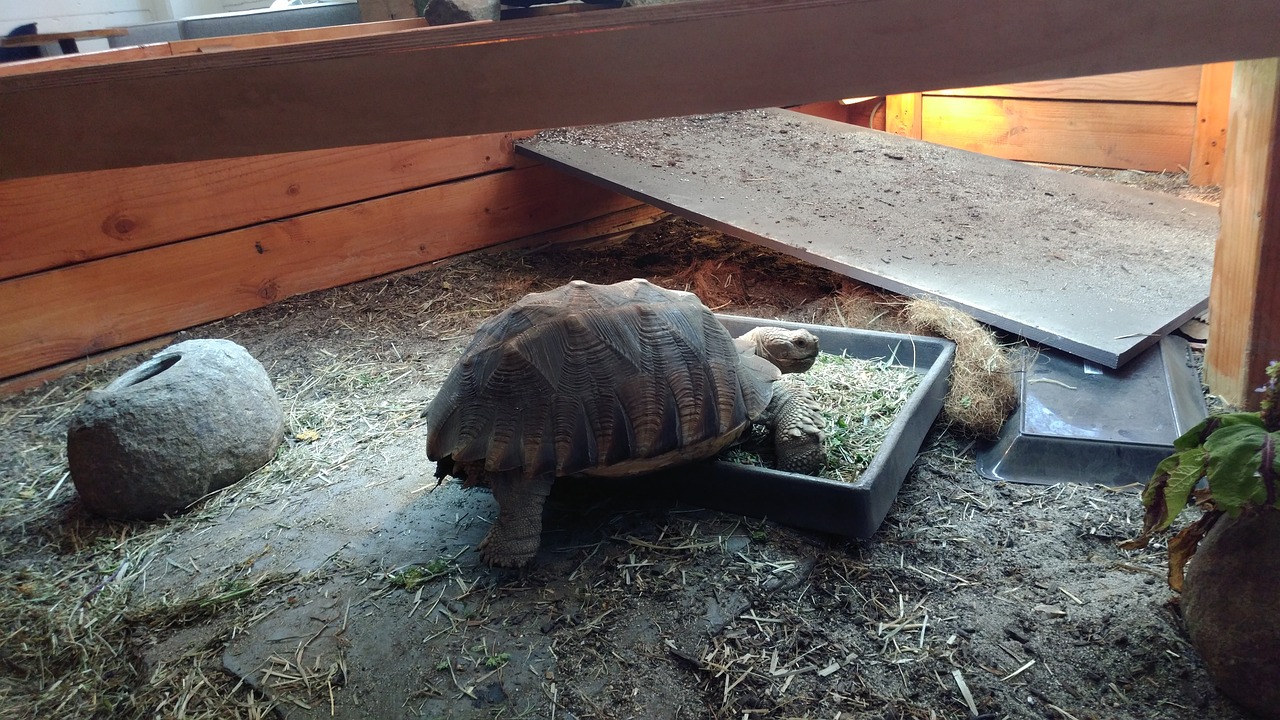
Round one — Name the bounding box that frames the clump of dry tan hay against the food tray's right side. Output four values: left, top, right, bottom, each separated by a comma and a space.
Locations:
905, 299, 1018, 438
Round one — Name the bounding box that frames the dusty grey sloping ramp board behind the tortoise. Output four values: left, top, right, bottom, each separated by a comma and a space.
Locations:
520, 110, 1217, 368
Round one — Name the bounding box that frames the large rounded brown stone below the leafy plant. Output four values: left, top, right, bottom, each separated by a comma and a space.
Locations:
1181, 509, 1280, 720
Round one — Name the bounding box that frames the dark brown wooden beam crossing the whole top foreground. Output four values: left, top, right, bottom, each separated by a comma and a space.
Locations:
0, 0, 1280, 178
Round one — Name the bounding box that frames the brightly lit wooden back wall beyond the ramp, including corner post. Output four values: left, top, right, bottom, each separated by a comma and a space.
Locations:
884, 63, 1231, 184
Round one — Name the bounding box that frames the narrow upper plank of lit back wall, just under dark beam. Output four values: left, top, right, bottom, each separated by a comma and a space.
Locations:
928, 65, 1201, 102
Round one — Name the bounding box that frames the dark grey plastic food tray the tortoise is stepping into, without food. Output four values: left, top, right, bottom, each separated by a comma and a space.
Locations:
557, 315, 955, 539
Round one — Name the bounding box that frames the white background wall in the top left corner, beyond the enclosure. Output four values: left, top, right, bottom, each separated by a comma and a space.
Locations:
0, 0, 271, 53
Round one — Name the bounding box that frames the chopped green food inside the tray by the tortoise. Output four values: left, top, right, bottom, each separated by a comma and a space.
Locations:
721, 352, 920, 483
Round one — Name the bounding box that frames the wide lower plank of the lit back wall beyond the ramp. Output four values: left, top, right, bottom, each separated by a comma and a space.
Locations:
922, 95, 1196, 172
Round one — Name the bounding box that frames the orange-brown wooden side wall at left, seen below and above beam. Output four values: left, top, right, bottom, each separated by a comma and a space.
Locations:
0, 20, 659, 391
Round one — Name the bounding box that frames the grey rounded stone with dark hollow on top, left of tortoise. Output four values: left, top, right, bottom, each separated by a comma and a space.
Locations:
67, 340, 284, 519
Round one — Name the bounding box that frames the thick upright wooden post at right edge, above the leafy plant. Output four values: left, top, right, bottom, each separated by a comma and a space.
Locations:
1204, 59, 1280, 409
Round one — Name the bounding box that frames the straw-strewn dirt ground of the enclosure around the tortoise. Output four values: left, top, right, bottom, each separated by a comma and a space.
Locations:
0, 197, 1244, 720
